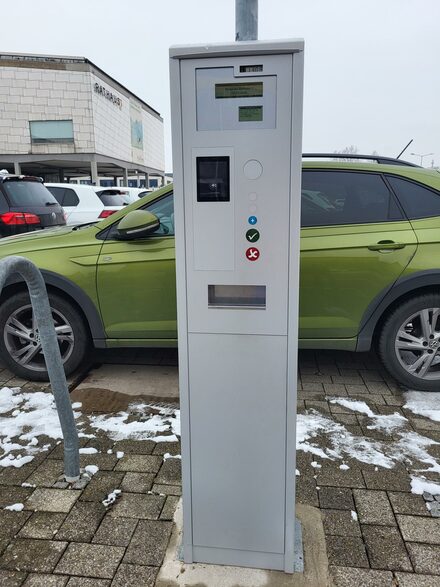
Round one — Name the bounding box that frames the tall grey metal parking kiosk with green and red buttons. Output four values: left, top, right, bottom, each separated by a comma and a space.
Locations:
170, 40, 304, 572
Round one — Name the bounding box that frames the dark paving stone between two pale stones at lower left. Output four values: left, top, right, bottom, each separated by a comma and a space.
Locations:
55, 501, 106, 542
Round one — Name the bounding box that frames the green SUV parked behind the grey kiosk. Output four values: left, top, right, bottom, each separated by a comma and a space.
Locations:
0, 157, 440, 391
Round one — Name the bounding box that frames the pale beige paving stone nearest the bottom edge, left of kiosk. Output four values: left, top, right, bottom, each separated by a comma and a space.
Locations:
55, 542, 124, 579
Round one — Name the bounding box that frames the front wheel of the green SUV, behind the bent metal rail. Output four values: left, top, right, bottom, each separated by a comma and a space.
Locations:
0, 291, 90, 381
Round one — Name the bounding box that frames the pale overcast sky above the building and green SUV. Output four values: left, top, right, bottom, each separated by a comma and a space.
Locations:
0, 0, 440, 171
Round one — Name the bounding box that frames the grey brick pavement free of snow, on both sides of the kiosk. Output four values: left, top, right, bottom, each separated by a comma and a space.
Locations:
0, 351, 440, 587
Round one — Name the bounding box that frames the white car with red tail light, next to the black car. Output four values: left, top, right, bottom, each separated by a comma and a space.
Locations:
44, 183, 127, 224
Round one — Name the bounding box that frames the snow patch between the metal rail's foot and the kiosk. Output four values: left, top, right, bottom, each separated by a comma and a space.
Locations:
90, 403, 180, 442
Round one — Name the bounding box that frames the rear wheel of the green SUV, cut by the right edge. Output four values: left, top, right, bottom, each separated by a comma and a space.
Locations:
378, 294, 440, 391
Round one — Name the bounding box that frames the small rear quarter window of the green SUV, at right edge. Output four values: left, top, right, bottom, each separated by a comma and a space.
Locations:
387, 175, 440, 220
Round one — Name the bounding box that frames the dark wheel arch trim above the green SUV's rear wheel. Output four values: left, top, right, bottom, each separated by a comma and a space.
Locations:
356, 269, 440, 352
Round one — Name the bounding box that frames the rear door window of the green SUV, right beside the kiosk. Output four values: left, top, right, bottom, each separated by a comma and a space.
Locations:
301, 170, 403, 227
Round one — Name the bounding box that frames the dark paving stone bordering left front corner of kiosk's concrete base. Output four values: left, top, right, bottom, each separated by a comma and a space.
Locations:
124, 520, 173, 567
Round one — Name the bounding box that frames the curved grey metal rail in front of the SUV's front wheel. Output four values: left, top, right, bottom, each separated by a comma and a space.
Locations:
0, 256, 80, 483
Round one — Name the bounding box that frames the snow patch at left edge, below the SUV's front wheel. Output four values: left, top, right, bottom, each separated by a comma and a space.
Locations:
0, 387, 80, 474
